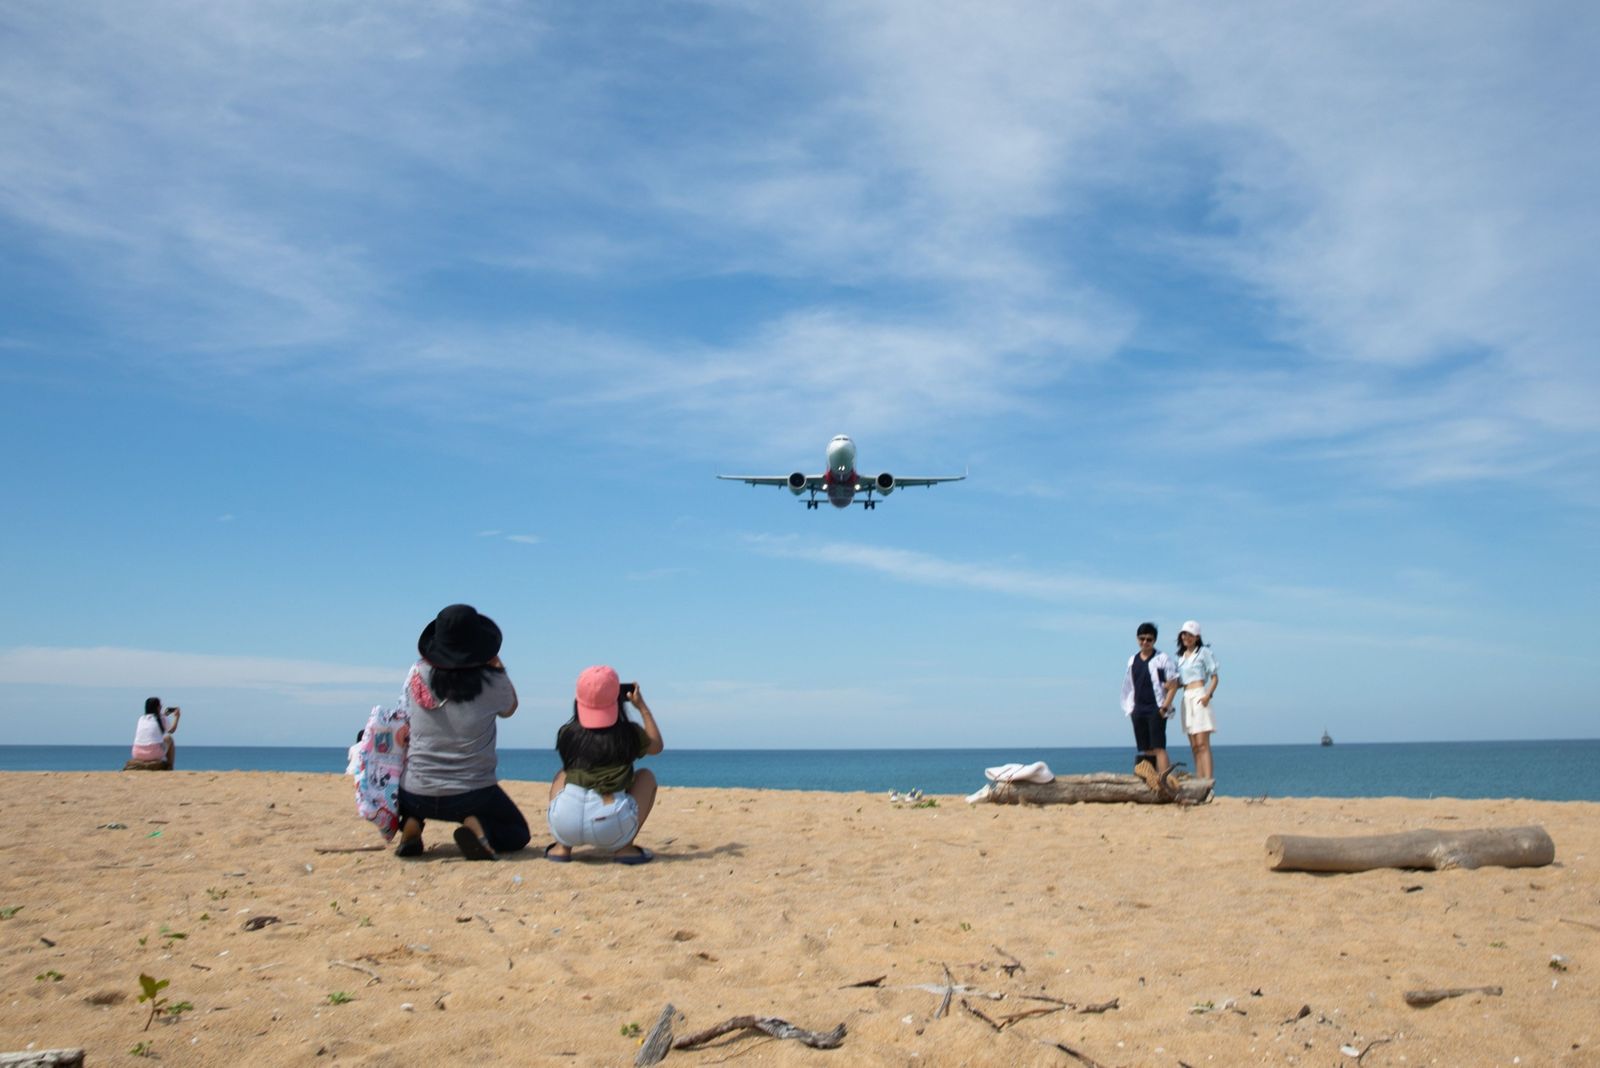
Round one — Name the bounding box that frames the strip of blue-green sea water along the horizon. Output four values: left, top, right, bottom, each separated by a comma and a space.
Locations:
0, 739, 1600, 801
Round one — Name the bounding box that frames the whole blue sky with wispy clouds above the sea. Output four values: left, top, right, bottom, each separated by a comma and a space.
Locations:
0, 0, 1600, 759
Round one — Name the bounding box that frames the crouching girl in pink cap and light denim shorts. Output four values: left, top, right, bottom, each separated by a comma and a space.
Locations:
544, 665, 662, 863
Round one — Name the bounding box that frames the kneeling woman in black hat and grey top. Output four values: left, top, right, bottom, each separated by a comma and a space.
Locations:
395, 604, 533, 860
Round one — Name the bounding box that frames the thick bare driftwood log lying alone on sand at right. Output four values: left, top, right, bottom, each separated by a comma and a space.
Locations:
1267, 827, 1555, 871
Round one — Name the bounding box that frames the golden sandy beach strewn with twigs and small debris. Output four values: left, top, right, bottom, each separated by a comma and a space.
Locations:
0, 771, 1600, 1068
